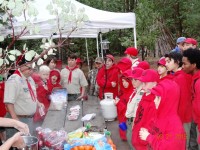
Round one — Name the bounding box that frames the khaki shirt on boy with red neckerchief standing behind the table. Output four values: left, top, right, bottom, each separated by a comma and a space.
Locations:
60, 68, 88, 94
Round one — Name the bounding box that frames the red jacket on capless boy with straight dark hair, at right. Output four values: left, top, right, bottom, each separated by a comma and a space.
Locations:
173, 70, 192, 123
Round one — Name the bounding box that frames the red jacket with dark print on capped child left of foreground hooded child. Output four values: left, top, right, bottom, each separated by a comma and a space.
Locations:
132, 94, 156, 150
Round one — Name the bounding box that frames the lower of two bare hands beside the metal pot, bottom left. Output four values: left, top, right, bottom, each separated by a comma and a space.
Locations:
11, 132, 26, 149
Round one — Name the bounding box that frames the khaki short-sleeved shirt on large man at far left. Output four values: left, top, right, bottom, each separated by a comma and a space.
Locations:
4, 71, 37, 115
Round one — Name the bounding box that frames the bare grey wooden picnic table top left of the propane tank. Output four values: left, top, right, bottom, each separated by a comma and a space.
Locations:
42, 96, 105, 132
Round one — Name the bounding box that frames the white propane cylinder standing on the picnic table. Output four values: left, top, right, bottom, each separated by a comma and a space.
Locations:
100, 93, 117, 121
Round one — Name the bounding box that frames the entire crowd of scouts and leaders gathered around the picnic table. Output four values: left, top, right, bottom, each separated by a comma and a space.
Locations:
0, 37, 200, 150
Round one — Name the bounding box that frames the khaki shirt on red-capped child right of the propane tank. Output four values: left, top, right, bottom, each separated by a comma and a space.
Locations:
125, 86, 144, 118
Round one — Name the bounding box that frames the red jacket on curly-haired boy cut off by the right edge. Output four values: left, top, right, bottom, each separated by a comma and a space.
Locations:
192, 71, 200, 131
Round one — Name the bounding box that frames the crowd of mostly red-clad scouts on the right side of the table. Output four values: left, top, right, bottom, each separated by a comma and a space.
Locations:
90, 37, 200, 150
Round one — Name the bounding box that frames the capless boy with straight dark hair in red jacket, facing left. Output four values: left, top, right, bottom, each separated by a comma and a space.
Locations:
166, 52, 192, 148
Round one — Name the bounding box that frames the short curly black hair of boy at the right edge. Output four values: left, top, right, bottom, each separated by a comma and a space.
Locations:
183, 48, 200, 69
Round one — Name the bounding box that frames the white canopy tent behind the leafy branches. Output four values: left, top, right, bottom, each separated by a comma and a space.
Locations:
0, 0, 137, 67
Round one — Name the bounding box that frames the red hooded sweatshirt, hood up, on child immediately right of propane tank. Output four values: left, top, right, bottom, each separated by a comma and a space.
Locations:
116, 77, 133, 140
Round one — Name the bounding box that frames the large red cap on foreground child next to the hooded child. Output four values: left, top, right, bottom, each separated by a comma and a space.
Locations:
137, 69, 159, 82
